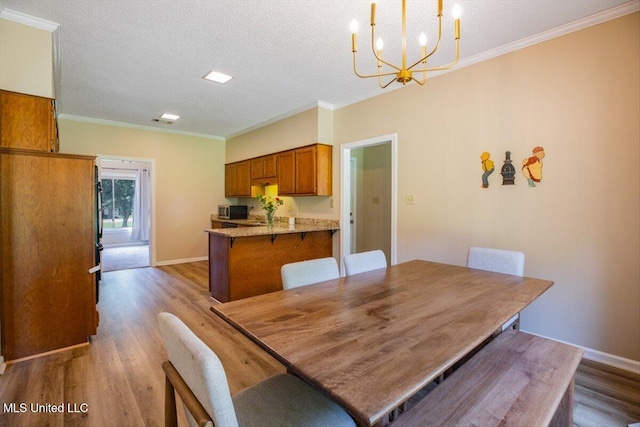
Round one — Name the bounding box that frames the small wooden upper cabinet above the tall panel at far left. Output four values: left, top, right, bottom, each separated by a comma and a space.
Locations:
0, 90, 58, 153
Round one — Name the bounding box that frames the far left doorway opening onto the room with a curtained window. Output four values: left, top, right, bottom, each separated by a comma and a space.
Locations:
96, 156, 152, 272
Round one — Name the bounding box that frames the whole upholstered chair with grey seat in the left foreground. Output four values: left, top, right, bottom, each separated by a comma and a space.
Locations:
158, 313, 355, 427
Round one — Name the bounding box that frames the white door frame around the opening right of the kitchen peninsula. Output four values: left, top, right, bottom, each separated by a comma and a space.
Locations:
340, 133, 398, 275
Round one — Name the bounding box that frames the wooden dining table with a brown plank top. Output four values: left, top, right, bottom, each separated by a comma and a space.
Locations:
211, 260, 553, 425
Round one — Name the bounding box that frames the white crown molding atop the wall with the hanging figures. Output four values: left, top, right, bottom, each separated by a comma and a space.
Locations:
333, 0, 640, 109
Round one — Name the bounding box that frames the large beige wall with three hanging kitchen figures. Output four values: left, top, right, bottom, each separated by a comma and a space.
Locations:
334, 13, 640, 361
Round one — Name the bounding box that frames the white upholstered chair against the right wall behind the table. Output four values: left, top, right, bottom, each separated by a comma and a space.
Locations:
467, 247, 524, 331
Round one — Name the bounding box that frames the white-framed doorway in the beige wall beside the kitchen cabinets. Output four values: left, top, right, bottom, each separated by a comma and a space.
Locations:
340, 134, 397, 273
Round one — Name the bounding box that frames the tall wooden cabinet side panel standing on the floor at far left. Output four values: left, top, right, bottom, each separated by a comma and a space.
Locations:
0, 147, 98, 360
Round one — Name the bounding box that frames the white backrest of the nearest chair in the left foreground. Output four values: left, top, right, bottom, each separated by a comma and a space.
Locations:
158, 313, 238, 426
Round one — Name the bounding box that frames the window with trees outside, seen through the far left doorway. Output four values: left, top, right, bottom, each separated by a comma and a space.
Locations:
102, 178, 136, 231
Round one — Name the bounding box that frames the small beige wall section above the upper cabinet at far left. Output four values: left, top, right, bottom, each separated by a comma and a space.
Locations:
0, 18, 55, 98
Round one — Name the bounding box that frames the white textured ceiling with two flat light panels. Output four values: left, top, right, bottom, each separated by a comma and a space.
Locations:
0, 0, 638, 137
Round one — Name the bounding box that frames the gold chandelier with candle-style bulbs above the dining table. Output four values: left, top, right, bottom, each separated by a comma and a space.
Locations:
351, 0, 461, 89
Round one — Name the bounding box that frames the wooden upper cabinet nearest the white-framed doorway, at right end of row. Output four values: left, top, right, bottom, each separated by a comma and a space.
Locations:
278, 144, 332, 196
